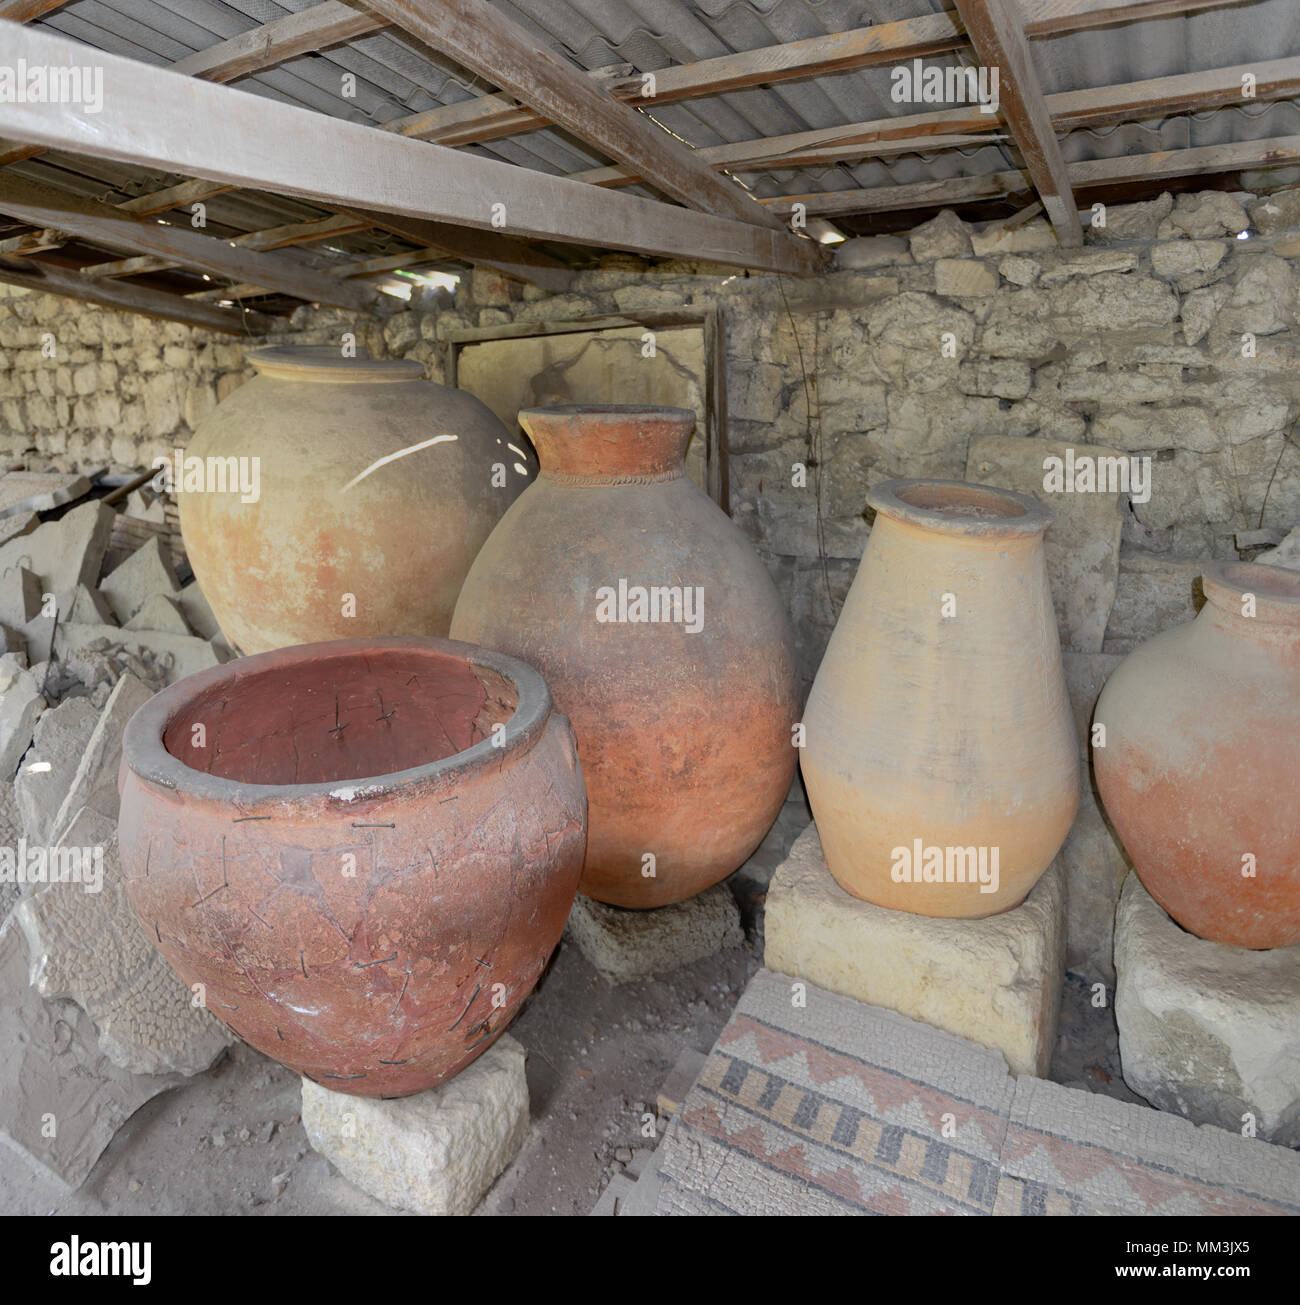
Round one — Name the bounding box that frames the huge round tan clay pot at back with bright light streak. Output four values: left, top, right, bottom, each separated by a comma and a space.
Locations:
172, 347, 535, 653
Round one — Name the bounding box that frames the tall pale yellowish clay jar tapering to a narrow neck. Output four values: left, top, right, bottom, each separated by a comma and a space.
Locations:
801, 480, 1081, 917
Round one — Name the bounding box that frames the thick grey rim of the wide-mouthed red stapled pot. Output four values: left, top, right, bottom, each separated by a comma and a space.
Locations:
121, 636, 552, 805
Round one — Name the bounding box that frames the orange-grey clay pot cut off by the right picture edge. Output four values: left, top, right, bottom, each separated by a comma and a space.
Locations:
1092, 562, 1300, 947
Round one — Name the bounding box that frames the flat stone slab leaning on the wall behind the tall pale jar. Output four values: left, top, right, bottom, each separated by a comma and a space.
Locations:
966, 435, 1129, 653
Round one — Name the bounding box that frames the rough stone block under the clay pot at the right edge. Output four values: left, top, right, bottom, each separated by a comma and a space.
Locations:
1115, 874, 1300, 1147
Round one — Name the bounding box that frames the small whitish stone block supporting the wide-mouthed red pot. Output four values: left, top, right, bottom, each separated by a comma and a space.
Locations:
303, 1034, 529, 1215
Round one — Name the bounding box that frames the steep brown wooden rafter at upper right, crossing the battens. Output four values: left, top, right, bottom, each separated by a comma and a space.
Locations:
955, 0, 1083, 245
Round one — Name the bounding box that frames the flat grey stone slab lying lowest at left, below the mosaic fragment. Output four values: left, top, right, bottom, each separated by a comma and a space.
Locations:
0, 917, 184, 1188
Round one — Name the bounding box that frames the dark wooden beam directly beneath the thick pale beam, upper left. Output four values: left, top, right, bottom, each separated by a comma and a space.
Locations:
0, 172, 373, 312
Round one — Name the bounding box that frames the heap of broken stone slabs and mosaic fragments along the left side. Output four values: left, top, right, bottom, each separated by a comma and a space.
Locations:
0, 472, 232, 1186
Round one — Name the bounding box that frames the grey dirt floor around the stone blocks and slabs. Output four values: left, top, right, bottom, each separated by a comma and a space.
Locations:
0, 805, 1169, 1215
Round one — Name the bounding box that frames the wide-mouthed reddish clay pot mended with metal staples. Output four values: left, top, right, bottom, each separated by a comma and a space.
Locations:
119, 638, 586, 1096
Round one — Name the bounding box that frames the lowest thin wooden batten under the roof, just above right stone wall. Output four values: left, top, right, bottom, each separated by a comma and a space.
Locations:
762, 136, 1300, 217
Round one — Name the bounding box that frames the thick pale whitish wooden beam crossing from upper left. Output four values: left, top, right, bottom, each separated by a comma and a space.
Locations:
0, 27, 825, 272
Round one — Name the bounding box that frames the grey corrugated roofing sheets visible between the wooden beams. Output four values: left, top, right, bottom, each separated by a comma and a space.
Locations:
15, 0, 1300, 257
